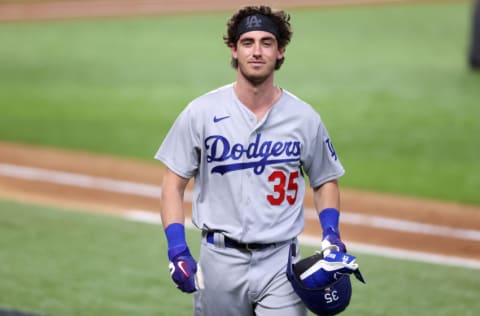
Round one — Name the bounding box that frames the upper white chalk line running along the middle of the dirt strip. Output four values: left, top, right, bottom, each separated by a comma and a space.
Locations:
0, 163, 480, 241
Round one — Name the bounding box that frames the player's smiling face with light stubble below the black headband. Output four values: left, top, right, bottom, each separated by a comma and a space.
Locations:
231, 31, 284, 84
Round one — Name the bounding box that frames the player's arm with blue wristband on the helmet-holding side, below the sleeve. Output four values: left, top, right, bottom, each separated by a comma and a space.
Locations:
313, 180, 346, 251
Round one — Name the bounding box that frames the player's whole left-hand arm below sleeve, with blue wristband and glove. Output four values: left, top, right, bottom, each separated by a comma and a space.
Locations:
160, 170, 200, 293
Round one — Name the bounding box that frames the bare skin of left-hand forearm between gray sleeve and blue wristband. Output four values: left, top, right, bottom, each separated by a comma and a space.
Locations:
160, 171, 188, 228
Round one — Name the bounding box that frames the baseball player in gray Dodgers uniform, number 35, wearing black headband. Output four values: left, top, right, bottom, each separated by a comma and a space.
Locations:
155, 6, 345, 316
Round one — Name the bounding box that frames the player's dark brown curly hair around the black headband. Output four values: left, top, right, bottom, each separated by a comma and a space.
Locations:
223, 6, 293, 70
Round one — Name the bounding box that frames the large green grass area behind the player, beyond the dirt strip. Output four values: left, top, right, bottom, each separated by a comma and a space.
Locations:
0, 2, 480, 204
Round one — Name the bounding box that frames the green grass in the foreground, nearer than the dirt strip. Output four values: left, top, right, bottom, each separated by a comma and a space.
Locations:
0, 201, 480, 316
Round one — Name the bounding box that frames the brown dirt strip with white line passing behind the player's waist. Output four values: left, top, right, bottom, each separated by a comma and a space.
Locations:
0, 142, 480, 260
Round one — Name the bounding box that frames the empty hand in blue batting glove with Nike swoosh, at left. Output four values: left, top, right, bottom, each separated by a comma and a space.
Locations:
168, 247, 201, 293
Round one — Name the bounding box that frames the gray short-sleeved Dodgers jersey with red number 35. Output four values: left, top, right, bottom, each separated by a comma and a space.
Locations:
155, 84, 344, 243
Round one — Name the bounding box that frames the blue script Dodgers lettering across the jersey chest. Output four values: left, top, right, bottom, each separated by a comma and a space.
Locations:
205, 134, 300, 175
